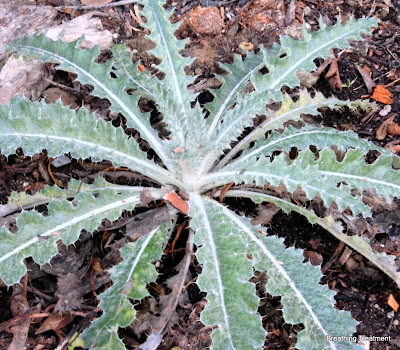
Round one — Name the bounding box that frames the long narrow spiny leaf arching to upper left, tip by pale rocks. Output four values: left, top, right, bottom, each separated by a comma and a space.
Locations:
9, 34, 172, 165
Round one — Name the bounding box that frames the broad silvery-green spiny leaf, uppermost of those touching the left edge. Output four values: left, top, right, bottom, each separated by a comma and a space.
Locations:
0, 98, 180, 187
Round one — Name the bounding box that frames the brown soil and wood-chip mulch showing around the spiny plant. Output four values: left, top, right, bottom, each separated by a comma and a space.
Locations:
0, 0, 400, 350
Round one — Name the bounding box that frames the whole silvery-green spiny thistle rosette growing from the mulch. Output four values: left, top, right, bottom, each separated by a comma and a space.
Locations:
0, 0, 400, 350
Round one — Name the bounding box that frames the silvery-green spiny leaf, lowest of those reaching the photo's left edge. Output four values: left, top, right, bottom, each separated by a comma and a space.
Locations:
0, 188, 153, 285
